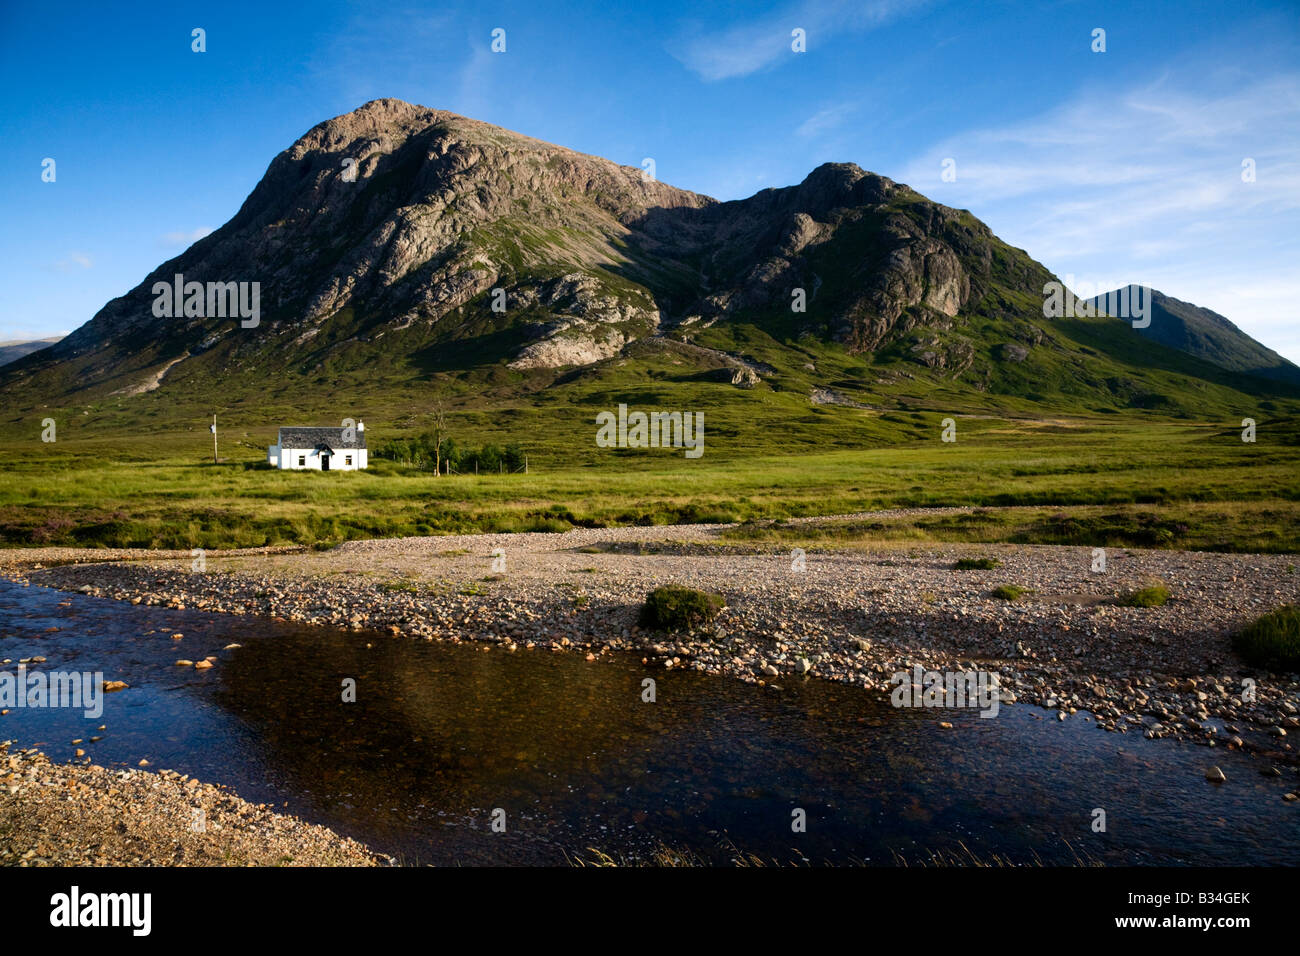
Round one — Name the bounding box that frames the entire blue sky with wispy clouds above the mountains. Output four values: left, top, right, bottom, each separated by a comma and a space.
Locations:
0, 0, 1300, 362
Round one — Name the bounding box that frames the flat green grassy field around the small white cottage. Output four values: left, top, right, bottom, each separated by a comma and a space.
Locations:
0, 408, 1300, 551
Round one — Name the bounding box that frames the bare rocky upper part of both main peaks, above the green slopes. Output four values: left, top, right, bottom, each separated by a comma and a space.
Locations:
10, 100, 1050, 393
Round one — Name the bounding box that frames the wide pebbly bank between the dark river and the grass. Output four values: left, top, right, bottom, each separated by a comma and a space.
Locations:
0, 515, 1300, 763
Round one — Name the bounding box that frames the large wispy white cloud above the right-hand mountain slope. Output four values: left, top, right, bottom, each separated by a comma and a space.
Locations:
901, 73, 1300, 360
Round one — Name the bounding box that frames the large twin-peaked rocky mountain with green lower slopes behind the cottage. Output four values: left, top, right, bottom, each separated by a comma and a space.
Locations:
0, 99, 1292, 427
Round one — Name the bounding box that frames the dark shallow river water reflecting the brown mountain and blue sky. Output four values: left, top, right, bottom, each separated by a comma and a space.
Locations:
0, 584, 1300, 864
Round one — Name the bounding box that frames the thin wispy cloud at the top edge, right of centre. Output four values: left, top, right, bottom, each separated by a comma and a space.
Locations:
668, 0, 923, 82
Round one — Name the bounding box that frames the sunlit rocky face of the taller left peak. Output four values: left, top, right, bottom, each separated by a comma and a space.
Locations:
43, 100, 711, 382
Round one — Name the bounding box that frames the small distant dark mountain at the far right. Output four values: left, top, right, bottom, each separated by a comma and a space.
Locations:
1089, 286, 1300, 385
